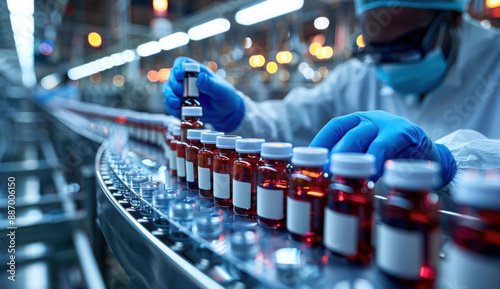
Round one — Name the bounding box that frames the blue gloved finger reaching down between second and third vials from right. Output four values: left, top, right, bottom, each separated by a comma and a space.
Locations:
366, 131, 408, 181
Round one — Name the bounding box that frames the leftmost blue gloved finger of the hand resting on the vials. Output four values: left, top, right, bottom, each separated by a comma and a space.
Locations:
309, 114, 361, 150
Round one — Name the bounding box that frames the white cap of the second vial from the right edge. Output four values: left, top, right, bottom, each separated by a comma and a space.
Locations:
384, 159, 441, 190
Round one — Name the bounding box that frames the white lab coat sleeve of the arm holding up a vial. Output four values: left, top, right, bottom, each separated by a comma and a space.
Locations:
232, 72, 339, 146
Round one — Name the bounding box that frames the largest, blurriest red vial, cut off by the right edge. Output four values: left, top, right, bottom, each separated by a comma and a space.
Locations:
441, 170, 500, 289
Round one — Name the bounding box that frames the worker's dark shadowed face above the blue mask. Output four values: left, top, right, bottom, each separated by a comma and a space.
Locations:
359, 7, 436, 45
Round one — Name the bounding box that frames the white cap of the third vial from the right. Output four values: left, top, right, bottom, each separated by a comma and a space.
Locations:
330, 153, 377, 178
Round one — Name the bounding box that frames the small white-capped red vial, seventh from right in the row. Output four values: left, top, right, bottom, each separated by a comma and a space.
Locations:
213, 135, 241, 208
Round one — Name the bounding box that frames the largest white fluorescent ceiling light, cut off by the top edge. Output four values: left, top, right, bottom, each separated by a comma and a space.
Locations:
235, 0, 304, 25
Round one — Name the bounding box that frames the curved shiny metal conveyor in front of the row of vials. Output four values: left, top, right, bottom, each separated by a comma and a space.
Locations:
96, 141, 454, 289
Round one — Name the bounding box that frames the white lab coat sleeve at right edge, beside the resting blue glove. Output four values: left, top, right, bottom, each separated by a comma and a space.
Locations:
436, 129, 500, 191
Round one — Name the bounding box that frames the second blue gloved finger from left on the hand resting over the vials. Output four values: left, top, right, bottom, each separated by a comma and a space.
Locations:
331, 122, 379, 153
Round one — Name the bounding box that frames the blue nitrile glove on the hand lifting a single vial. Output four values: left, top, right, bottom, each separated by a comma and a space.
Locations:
163, 57, 245, 132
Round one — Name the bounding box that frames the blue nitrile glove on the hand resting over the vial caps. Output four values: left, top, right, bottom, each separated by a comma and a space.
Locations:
310, 111, 457, 186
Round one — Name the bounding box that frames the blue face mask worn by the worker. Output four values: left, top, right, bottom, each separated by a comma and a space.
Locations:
375, 48, 448, 94
